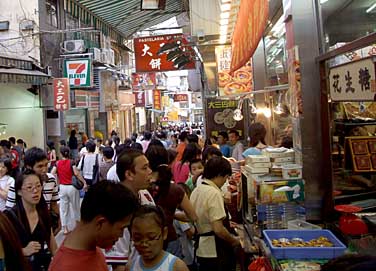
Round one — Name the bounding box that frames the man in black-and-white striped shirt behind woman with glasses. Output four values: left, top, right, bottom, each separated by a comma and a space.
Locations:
6, 147, 59, 228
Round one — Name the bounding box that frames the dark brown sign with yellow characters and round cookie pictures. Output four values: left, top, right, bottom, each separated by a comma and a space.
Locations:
206, 98, 244, 139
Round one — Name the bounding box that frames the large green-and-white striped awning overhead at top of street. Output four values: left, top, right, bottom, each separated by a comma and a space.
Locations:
70, 0, 188, 38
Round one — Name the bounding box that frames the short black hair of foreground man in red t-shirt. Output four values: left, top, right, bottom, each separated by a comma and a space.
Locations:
81, 181, 139, 224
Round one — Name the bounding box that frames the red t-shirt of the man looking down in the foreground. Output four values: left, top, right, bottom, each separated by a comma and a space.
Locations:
48, 246, 108, 271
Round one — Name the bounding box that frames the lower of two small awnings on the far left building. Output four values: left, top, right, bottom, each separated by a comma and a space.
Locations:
0, 68, 50, 85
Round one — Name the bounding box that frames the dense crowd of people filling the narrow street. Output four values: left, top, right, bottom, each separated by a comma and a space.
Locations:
0, 124, 374, 271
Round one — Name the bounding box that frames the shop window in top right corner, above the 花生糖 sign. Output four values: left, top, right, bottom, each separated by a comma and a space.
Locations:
318, 0, 376, 51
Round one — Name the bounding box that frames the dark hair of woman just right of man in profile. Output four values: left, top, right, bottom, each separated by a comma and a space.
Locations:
145, 145, 172, 199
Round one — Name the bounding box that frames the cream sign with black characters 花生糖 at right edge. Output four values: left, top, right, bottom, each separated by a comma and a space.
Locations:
329, 58, 376, 101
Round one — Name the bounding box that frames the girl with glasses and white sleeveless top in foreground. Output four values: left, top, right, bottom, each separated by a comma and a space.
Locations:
127, 205, 189, 271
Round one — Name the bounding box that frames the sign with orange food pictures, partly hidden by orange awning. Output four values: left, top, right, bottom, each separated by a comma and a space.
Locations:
215, 46, 253, 96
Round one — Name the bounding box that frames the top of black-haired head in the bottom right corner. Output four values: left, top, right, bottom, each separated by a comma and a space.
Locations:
321, 254, 376, 271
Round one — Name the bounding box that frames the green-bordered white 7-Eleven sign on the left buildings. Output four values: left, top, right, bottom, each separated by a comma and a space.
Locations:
64, 58, 91, 88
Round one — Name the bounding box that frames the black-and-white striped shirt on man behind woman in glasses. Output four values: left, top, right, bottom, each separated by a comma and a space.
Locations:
6, 173, 59, 208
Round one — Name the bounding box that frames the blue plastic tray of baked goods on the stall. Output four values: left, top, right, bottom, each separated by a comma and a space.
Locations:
263, 230, 346, 259
